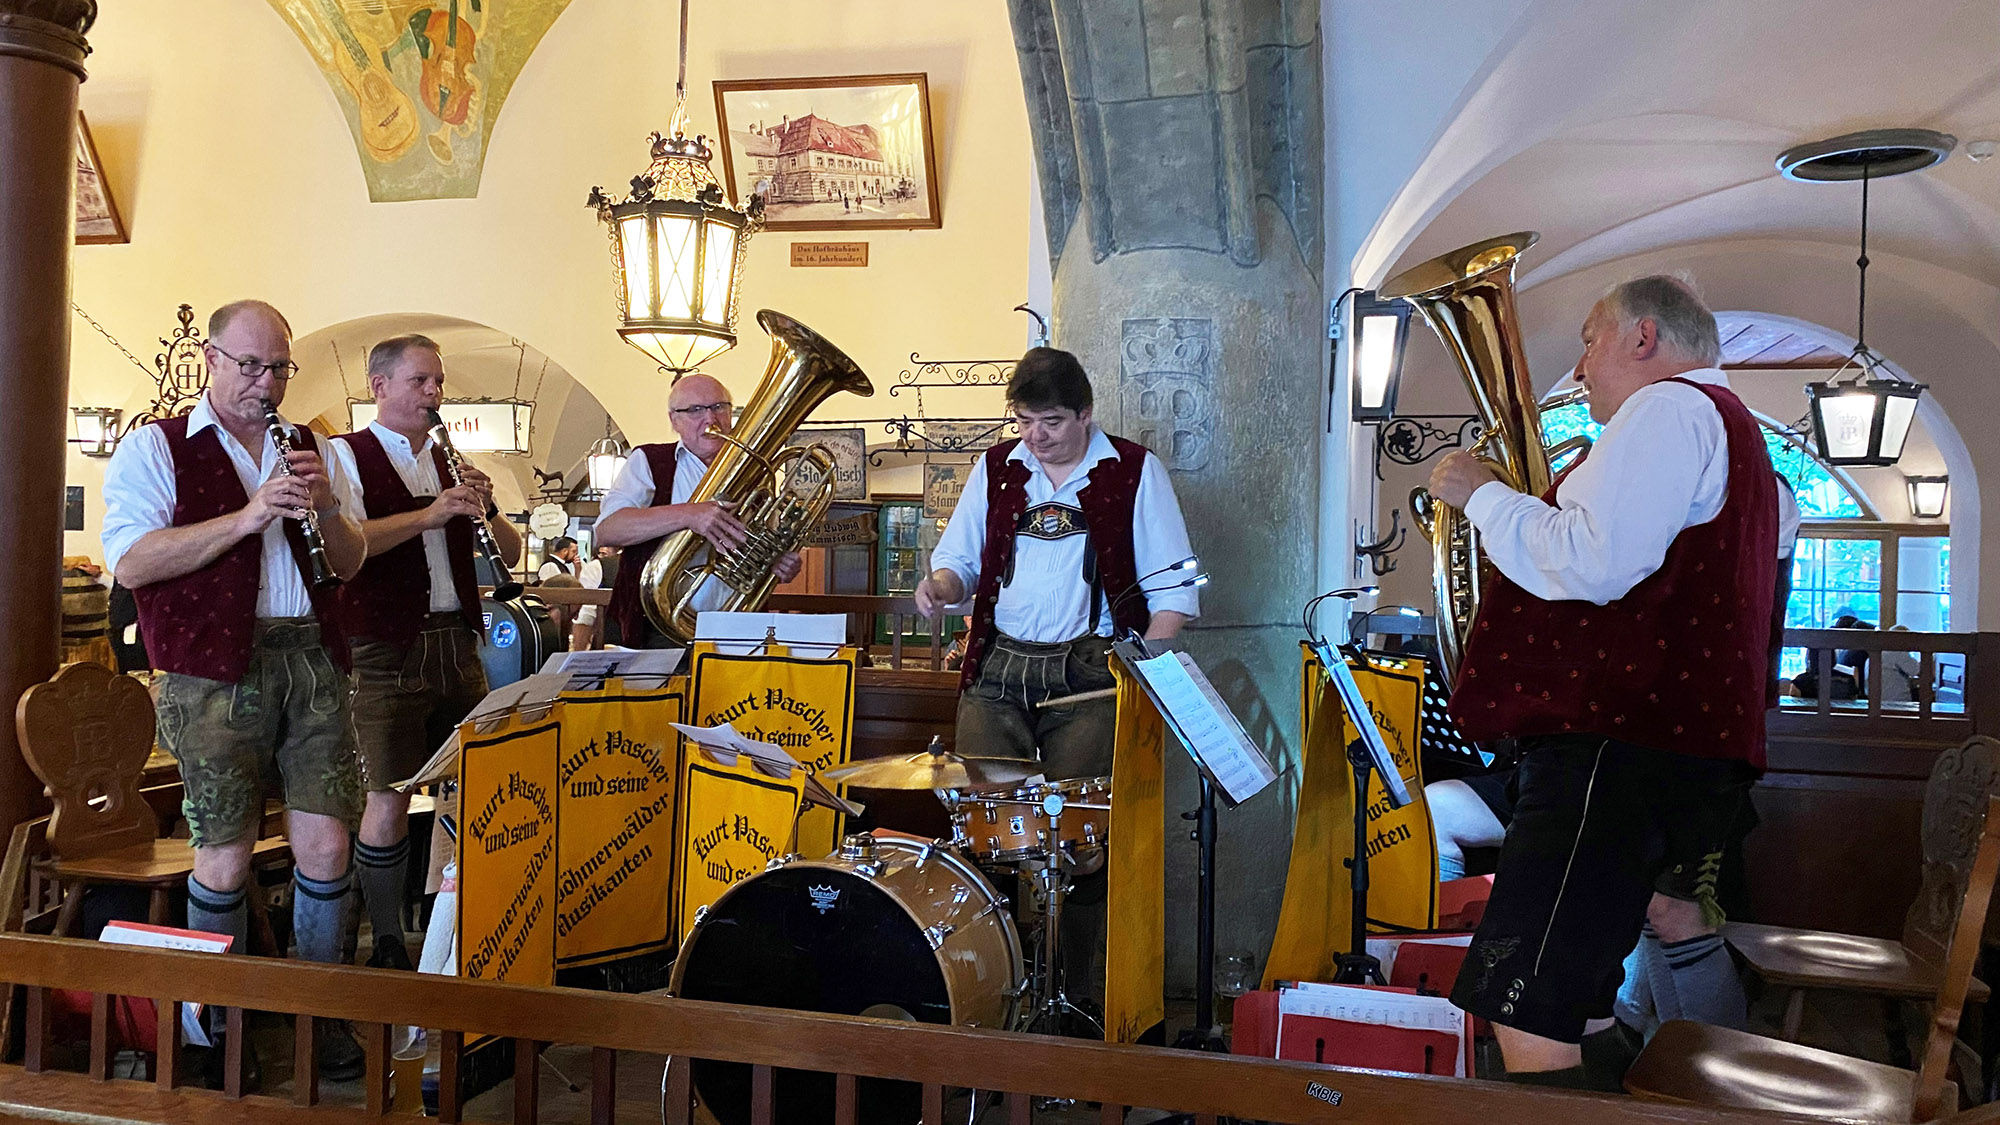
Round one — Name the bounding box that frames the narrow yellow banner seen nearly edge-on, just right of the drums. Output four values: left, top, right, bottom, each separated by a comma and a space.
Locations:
1104, 661, 1166, 1043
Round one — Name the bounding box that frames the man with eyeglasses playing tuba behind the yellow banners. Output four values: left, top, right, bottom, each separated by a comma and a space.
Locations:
596, 374, 800, 649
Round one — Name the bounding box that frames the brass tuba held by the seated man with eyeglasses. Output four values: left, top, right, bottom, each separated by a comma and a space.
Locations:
640, 308, 874, 645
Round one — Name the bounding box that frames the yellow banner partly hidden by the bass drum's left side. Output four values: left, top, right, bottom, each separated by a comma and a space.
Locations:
674, 747, 804, 933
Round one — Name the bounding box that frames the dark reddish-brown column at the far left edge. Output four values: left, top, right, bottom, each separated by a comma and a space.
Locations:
0, 0, 98, 847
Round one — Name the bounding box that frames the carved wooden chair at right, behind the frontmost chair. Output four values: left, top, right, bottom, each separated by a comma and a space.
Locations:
1722, 735, 2000, 1041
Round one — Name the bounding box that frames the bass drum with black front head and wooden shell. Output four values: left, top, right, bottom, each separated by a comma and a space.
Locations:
668, 837, 1024, 1125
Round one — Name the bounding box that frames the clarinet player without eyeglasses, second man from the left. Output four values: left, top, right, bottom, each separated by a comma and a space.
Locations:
328, 334, 520, 969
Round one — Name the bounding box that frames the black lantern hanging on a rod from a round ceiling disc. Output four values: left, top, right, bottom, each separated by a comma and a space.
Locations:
1778, 128, 1958, 466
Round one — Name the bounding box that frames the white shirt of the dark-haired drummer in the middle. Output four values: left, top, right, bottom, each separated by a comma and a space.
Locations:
930, 426, 1202, 645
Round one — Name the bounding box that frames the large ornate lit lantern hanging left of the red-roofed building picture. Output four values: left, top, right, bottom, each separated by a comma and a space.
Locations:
590, 0, 764, 376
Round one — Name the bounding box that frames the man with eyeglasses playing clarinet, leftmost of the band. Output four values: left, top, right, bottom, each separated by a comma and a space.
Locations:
104, 300, 368, 1079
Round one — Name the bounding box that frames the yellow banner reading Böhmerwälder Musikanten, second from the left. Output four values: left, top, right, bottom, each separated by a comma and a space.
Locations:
556, 679, 688, 967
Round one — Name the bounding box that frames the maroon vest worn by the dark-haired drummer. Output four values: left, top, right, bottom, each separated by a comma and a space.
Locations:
958, 434, 1152, 691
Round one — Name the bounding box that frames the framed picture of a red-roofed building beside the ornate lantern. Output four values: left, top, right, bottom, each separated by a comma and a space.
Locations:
716, 74, 944, 230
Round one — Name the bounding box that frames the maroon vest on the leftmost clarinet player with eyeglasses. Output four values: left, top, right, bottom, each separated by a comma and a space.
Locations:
132, 414, 348, 683
